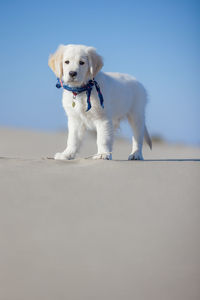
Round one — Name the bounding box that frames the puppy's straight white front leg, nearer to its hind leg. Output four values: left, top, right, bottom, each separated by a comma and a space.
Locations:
93, 120, 113, 160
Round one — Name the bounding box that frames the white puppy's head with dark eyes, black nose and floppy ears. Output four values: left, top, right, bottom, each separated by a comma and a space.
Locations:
49, 45, 103, 86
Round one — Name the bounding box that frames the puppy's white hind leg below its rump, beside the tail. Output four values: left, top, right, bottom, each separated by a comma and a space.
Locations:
127, 113, 145, 160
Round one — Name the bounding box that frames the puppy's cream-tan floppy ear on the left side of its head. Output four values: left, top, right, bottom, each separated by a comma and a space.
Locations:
48, 45, 65, 79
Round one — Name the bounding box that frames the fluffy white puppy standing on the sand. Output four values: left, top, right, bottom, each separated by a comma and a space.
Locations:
49, 45, 152, 160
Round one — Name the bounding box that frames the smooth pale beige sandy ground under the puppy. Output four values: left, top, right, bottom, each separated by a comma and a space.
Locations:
0, 129, 200, 300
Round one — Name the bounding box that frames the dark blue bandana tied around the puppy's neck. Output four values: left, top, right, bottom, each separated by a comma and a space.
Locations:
56, 78, 104, 111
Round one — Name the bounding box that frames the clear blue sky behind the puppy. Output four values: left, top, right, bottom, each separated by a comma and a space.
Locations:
0, 0, 200, 144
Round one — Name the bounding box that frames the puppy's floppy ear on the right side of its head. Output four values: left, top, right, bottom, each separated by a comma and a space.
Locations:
88, 47, 103, 78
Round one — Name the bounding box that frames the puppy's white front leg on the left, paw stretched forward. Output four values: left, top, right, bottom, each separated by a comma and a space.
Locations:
54, 118, 85, 160
